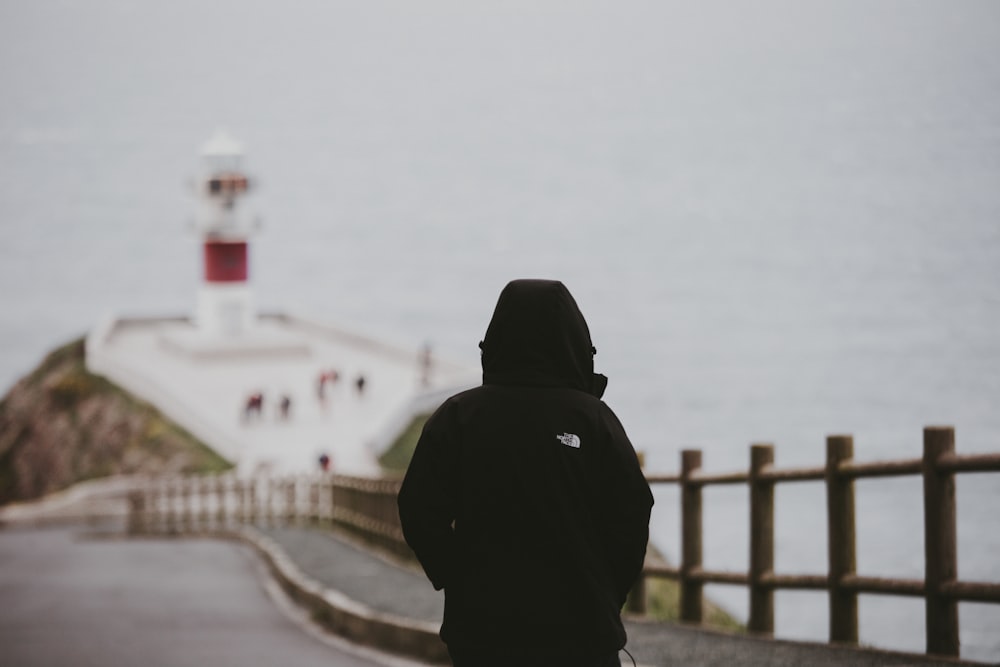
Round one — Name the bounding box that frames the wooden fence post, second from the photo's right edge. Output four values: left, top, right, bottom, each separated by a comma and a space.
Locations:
826, 435, 858, 644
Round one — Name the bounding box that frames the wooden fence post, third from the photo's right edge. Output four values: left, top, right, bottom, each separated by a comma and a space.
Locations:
747, 444, 774, 635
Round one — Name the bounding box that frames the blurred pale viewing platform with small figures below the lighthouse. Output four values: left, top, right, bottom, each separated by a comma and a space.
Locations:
86, 314, 479, 476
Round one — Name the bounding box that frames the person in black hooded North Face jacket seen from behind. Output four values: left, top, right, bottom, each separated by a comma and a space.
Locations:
398, 280, 653, 667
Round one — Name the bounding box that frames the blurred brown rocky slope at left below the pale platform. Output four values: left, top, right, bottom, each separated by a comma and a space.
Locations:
0, 339, 230, 505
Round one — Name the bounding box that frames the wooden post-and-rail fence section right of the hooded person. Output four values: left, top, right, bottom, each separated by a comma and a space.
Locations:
643, 427, 1000, 657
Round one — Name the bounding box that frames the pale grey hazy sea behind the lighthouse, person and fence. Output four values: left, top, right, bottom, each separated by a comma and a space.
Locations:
0, 0, 1000, 660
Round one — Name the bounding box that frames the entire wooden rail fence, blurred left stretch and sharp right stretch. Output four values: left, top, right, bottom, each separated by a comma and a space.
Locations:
130, 427, 1000, 656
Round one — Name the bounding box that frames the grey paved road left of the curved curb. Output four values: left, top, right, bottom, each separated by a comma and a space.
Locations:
0, 528, 426, 667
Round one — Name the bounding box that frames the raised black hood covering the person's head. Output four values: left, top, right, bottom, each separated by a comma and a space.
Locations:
479, 280, 608, 397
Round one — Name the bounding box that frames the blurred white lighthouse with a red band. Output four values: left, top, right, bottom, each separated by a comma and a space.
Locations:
195, 131, 256, 339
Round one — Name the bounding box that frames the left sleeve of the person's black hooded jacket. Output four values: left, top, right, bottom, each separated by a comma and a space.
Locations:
397, 408, 457, 590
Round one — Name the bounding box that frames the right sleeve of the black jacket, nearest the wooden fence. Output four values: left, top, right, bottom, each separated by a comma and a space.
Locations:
600, 406, 653, 606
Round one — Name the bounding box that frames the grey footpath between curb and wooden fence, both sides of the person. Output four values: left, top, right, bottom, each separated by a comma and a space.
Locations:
256, 527, 978, 667
